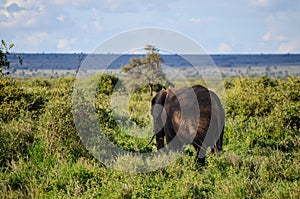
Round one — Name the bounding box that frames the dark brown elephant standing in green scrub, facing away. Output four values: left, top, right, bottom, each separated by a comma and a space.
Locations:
149, 85, 225, 165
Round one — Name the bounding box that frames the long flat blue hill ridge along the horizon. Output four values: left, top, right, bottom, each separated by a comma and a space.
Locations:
9, 53, 300, 70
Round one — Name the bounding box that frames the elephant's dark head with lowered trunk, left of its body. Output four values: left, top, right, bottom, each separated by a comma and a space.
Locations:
150, 90, 168, 149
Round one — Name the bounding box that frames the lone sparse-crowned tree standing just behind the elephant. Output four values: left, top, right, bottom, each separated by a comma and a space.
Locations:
121, 45, 166, 96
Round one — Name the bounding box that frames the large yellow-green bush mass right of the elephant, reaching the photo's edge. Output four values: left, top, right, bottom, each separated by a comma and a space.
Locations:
226, 77, 300, 152
